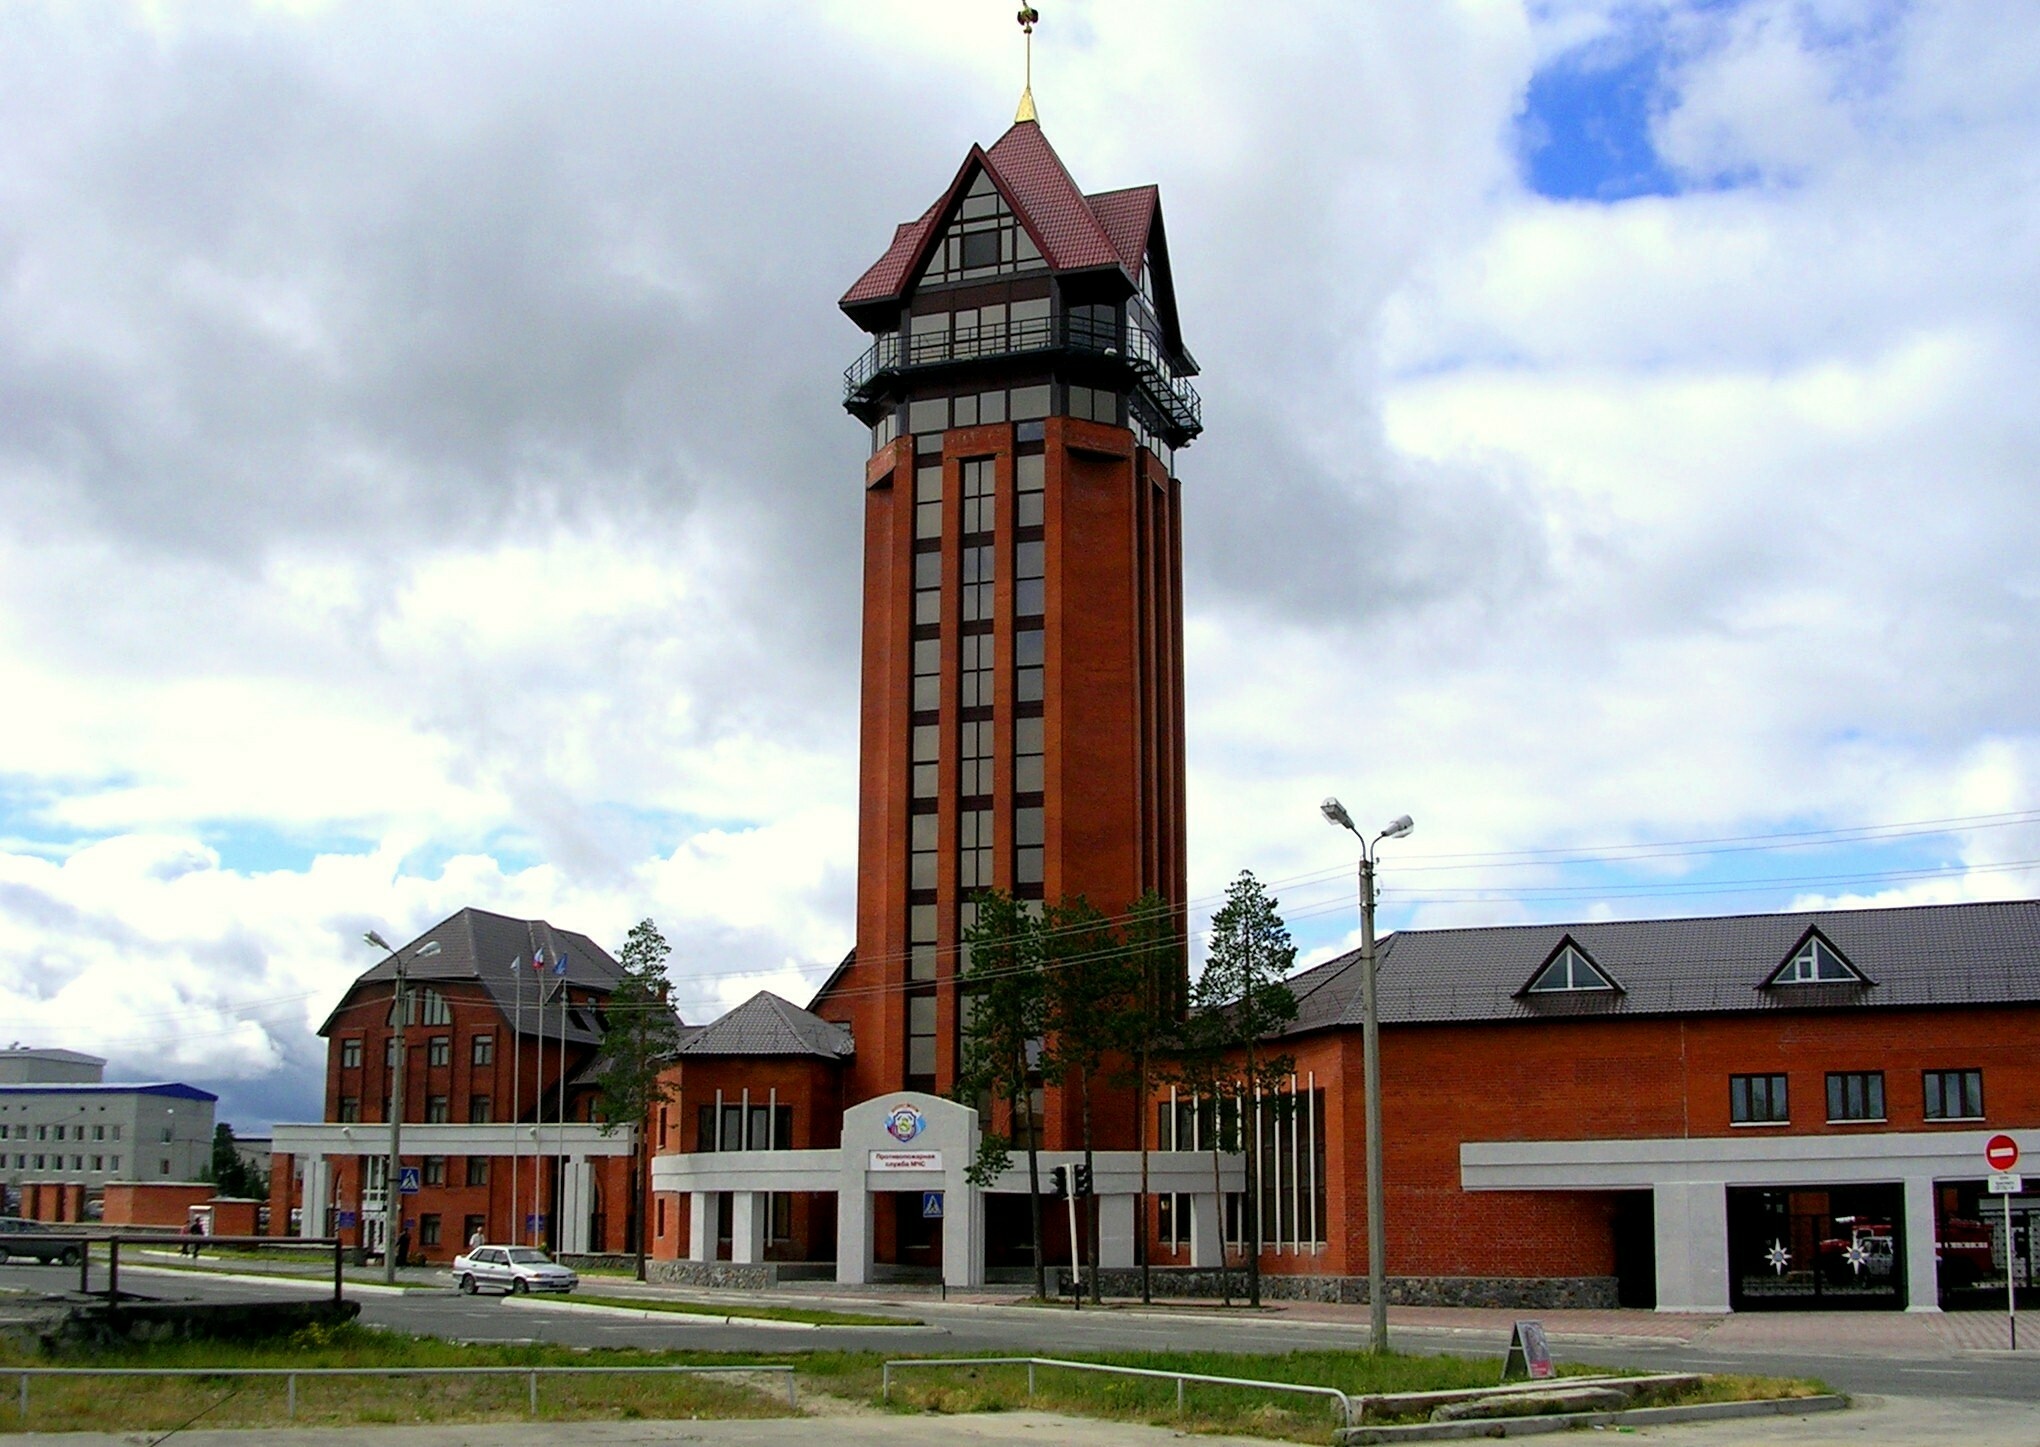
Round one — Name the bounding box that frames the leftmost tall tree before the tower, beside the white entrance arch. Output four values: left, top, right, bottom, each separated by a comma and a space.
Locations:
957, 890, 1049, 1296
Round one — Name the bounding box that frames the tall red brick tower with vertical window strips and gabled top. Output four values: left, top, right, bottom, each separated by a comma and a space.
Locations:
816, 102, 1202, 1147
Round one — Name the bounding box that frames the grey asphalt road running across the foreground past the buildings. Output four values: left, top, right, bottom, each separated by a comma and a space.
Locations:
95, 1265, 2040, 1404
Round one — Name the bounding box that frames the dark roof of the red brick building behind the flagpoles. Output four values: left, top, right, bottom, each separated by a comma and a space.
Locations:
318, 908, 622, 1045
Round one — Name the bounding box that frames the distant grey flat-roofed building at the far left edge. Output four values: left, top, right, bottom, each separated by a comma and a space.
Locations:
0, 1045, 218, 1198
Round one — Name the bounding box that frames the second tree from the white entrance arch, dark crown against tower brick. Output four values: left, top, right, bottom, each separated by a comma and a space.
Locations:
1040, 894, 1144, 1302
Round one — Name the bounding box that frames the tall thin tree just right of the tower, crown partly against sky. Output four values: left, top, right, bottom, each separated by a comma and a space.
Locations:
1197, 869, 1297, 1306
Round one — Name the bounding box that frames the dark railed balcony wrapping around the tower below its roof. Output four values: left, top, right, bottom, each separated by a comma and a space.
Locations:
843, 316, 1204, 447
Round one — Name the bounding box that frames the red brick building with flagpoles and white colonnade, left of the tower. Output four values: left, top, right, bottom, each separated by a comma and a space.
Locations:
269, 908, 643, 1261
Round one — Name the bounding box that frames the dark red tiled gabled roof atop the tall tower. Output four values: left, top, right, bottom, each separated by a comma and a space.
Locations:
843, 120, 1161, 306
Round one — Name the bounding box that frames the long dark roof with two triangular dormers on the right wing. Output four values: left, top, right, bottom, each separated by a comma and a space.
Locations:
1285, 900, 2040, 1035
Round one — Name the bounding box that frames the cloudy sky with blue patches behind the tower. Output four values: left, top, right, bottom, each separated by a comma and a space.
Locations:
0, 0, 2040, 1131
